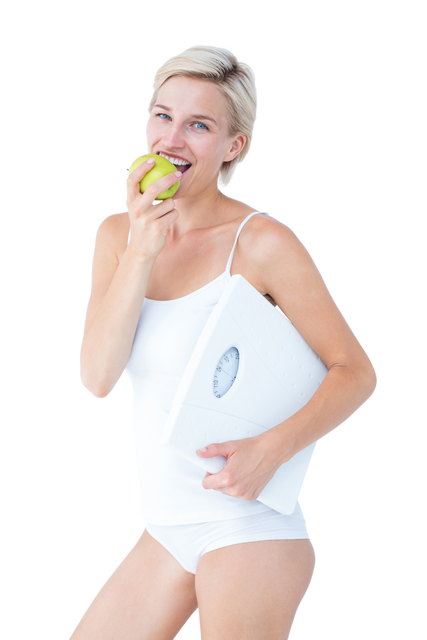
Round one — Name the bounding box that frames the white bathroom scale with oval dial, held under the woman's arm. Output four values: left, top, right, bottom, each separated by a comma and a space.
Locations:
160, 274, 328, 515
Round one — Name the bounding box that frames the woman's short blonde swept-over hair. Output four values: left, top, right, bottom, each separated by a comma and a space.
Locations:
144, 38, 266, 193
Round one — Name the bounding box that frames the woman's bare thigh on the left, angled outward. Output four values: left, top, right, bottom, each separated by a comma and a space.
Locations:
71, 529, 197, 640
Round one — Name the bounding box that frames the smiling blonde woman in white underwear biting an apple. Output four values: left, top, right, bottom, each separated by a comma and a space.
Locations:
73, 43, 377, 640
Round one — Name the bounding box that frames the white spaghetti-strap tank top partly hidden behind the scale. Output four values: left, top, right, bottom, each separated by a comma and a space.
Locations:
125, 209, 278, 525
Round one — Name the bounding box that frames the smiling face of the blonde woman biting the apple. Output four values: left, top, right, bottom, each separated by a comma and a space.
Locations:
144, 76, 246, 200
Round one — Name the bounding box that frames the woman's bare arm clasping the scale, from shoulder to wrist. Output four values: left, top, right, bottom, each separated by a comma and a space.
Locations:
249, 219, 379, 464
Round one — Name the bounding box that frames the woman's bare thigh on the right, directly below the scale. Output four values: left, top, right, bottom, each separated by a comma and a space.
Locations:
196, 539, 315, 640
